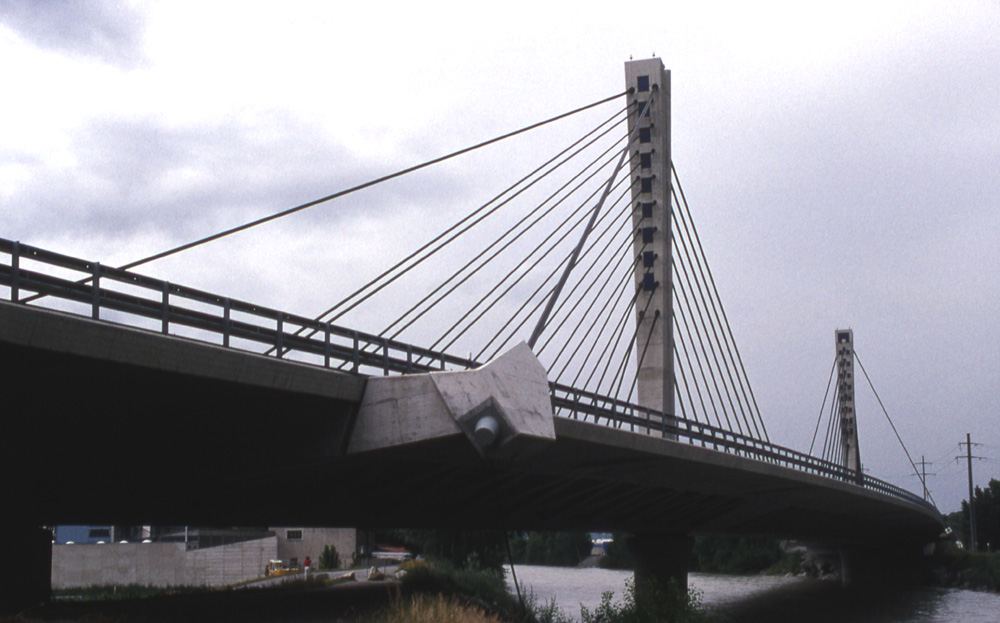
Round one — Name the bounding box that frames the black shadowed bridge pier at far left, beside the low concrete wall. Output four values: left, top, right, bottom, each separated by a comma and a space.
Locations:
0, 525, 52, 614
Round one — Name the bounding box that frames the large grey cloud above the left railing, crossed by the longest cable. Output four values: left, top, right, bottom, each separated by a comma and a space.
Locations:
4, 114, 480, 243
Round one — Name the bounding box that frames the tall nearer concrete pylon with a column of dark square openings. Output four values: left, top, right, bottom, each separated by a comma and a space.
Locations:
625, 58, 674, 423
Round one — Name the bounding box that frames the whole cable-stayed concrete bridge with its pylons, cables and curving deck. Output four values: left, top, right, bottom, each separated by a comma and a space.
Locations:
0, 59, 943, 608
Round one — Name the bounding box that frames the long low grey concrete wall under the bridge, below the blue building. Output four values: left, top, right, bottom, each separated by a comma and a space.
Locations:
52, 537, 278, 589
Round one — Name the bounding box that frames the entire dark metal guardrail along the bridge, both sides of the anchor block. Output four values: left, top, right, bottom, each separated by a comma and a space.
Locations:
0, 238, 936, 510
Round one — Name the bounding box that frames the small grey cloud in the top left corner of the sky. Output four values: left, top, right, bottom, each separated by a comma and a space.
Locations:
0, 0, 144, 69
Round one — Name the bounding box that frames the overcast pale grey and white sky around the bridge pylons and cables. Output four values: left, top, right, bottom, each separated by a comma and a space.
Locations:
0, 0, 1000, 512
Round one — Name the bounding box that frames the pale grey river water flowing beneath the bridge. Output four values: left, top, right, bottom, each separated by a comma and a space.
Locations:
507, 565, 1000, 623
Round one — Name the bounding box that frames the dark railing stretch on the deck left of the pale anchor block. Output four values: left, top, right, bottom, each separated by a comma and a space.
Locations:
0, 239, 476, 375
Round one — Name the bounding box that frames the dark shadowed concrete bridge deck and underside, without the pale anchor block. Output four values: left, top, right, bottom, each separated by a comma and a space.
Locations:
0, 303, 942, 542
